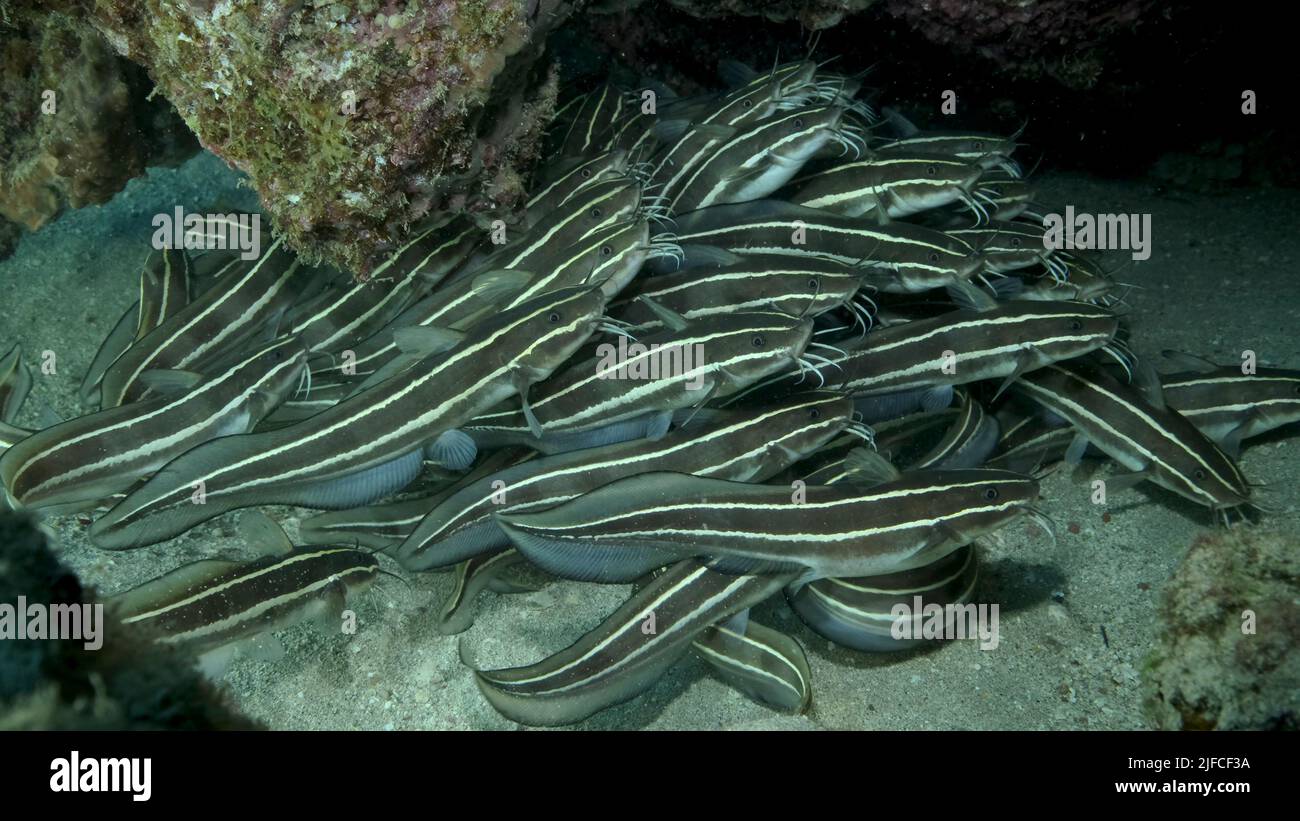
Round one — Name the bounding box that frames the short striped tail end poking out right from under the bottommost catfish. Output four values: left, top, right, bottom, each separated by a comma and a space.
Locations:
692, 611, 813, 713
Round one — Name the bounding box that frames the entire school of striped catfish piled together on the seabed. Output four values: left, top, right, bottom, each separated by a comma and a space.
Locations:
0, 61, 1300, 725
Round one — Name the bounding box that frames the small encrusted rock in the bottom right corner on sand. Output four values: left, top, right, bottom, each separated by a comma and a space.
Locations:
1144, 527, 1300, 730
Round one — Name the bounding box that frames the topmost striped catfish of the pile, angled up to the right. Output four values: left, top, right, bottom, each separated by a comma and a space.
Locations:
649, 61, 816, 201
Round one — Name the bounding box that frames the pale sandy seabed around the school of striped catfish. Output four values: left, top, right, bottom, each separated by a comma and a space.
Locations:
0, 153, 1300, 729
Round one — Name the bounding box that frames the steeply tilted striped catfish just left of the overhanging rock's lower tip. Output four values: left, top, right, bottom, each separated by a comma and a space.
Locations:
100, 239, 300, 408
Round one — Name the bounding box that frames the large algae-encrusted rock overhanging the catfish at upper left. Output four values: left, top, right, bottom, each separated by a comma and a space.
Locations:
78, 0, 568, 274
